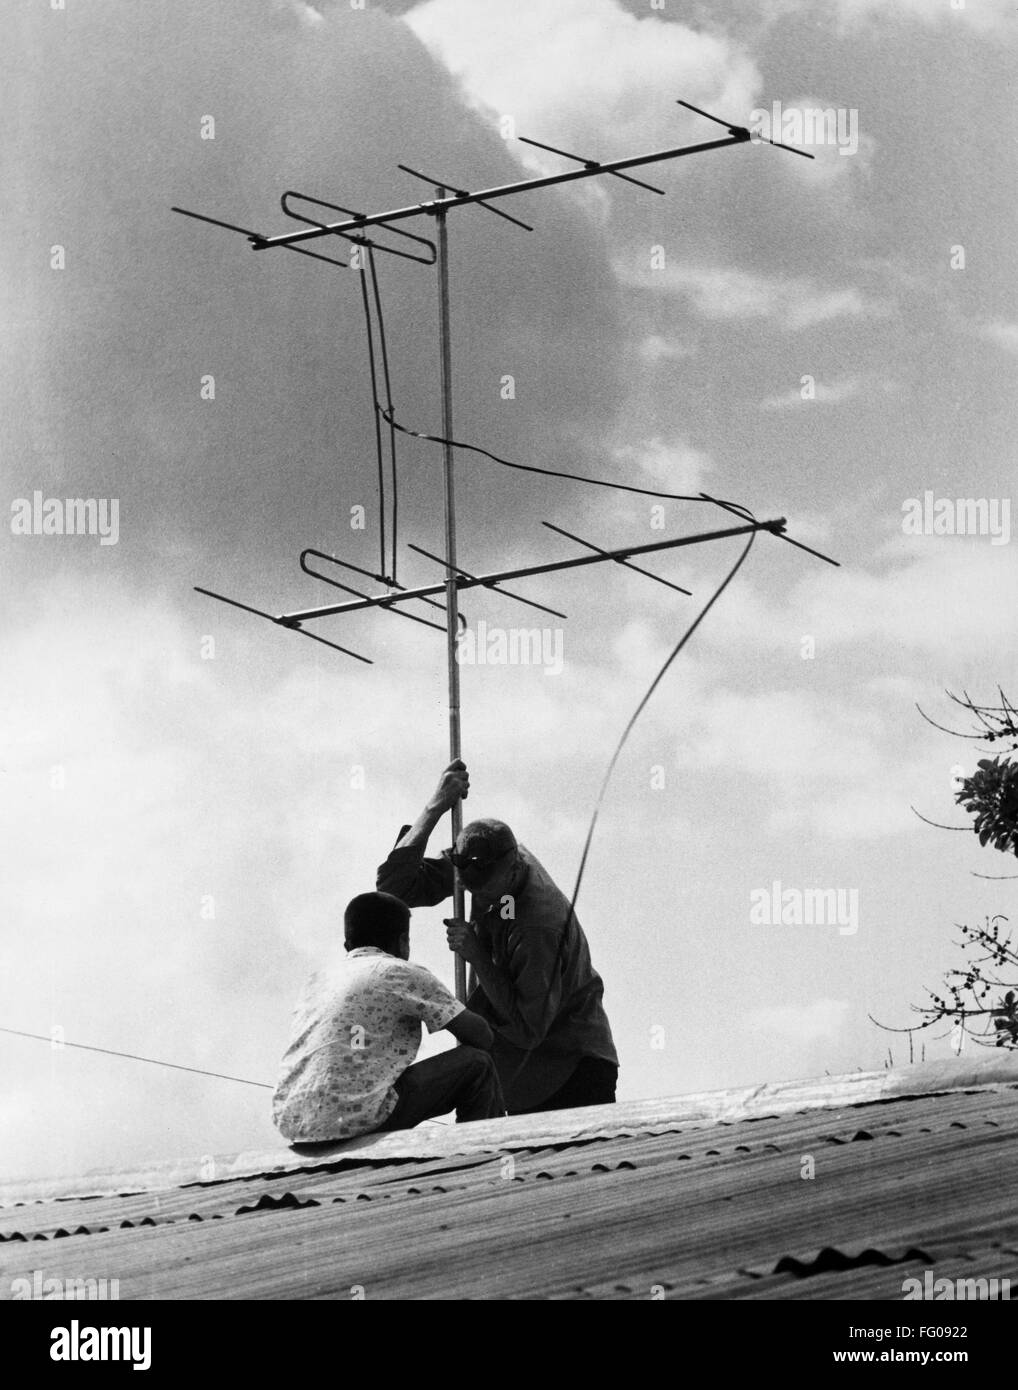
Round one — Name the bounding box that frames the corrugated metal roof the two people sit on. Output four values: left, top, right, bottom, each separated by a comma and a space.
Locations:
0, 1056, 1018, 1300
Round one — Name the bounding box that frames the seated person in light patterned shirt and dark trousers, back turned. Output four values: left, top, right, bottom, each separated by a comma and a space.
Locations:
273, 892, 505, 1144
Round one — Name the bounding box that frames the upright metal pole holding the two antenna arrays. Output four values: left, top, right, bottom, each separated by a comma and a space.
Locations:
435, 188, 466, 1004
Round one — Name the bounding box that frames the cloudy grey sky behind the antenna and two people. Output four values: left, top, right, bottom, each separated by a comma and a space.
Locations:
0, 0, 1018, 1175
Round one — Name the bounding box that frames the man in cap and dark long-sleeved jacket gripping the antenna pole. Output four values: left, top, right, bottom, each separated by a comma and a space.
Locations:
377, 759, 619, 1115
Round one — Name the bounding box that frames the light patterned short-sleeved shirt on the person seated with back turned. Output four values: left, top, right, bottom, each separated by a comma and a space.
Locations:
273, 947, 463, 1143
